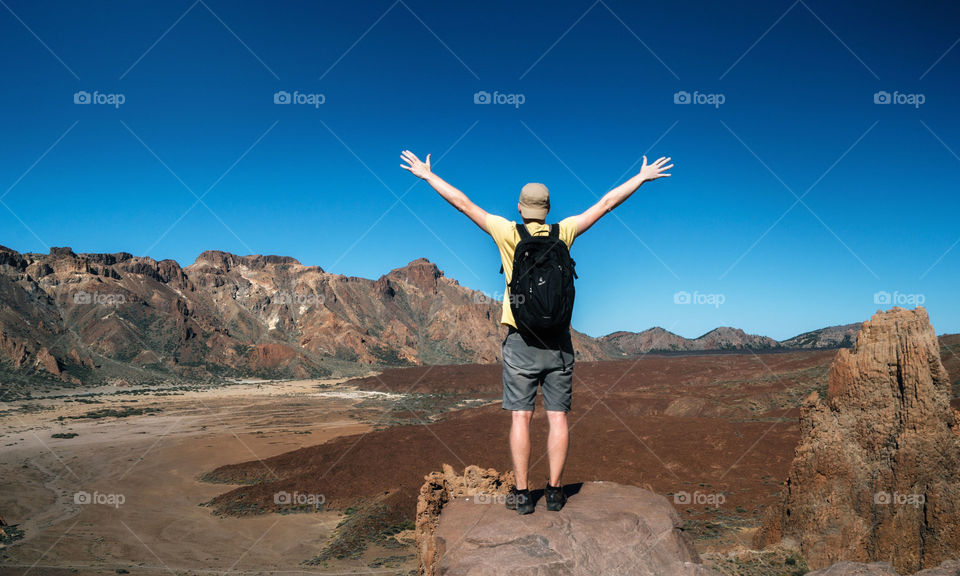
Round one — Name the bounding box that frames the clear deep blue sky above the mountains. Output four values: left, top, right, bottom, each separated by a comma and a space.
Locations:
0, 0, 960, 339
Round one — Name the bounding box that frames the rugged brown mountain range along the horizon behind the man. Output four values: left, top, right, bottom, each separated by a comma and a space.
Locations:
0, 246, 860, 392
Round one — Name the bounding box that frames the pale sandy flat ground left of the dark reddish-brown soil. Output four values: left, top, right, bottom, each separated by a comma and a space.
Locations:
0, 380, 415, 576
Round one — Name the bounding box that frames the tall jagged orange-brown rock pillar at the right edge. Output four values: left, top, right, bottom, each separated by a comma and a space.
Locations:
754, 308, 960, 574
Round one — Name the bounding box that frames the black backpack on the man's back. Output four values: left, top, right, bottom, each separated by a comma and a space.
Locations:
501, 223, 577, 337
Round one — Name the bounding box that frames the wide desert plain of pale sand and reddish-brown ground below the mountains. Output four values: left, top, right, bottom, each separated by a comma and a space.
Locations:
0, 336, 960, 576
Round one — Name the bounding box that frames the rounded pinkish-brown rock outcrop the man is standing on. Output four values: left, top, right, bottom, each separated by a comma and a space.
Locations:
417, 466, 719, 576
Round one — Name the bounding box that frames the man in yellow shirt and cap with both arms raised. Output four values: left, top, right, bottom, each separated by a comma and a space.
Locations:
400, 150, 673, 514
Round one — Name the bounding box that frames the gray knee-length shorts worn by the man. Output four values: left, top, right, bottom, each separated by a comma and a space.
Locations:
501, 328, 574, 412
